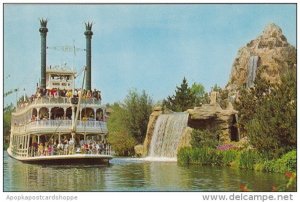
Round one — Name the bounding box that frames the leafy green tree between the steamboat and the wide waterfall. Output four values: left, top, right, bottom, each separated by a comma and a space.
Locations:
108, 90, 153, 156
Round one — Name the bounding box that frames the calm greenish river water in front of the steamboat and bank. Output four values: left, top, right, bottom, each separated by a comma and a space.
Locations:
3, 152, 285, 192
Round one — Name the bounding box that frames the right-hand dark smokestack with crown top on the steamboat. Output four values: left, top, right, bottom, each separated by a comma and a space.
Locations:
84, 22, 93, 90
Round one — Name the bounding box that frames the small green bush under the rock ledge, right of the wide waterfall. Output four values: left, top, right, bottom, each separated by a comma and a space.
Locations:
191, 129, 219, 148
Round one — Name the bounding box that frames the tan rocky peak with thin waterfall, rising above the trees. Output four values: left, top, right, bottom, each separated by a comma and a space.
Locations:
227, 24, 297, 90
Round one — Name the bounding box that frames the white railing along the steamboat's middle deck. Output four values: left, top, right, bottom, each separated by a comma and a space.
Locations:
12, 120, 108, 133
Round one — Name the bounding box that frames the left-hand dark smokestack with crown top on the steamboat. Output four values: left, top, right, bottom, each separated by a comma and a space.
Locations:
39, 18, 48, 88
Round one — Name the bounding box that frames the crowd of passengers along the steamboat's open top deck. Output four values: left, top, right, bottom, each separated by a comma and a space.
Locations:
18, 87, 102, 107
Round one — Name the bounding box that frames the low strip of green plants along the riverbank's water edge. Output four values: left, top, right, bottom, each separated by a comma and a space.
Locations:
177, 147, 297, 173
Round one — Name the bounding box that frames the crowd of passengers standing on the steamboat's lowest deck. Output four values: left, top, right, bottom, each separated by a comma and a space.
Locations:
30, 138, 109, 156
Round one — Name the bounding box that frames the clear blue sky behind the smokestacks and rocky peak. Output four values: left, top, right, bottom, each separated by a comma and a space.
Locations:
3, 4, 296, 105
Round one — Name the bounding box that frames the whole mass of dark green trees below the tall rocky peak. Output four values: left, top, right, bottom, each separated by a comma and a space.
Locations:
237, 70, 297, 159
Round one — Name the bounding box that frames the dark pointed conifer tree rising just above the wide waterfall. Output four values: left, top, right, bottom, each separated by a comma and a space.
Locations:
163, 78, 196, 112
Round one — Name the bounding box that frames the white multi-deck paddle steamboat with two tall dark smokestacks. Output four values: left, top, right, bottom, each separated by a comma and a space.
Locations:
7, 19, 112, 164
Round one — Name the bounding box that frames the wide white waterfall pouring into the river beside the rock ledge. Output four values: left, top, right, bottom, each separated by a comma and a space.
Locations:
148, 112, 188, 158
